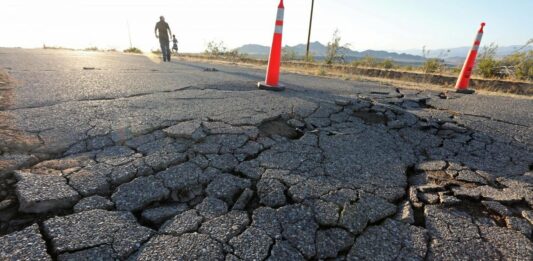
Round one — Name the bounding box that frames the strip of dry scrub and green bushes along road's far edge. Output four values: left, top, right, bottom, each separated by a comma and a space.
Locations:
193, 33, 533, 82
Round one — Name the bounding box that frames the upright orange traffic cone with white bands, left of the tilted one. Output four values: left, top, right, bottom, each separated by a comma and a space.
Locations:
257, 0, 285, 91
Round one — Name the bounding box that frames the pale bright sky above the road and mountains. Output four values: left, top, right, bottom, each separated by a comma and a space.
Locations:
0, 0, 533, 52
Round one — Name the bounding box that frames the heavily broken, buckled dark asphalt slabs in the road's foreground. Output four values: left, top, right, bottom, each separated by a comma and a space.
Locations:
0, 93, 533, 260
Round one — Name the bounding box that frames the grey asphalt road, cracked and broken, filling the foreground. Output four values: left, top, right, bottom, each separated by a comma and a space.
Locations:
0, 49, 533, 260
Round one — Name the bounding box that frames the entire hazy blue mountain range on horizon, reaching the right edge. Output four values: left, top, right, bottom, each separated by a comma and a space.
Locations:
237, 42, 533, 65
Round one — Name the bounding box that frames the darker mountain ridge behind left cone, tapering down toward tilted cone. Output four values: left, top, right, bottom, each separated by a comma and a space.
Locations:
237, 42, 425, 64
